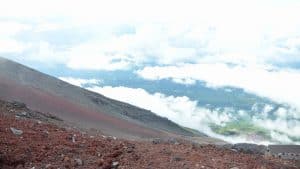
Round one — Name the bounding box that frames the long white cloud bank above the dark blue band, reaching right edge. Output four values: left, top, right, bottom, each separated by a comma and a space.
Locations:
137, 63, 300, 111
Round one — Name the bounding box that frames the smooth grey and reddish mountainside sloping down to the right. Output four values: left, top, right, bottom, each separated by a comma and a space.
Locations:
0, 58, 220, 142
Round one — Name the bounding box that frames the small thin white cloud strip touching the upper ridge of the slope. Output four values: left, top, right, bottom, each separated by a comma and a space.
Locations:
59, 77, 102, 87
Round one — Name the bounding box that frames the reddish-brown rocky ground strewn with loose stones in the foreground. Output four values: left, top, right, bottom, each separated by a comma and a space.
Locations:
0, 101, 299, 169
